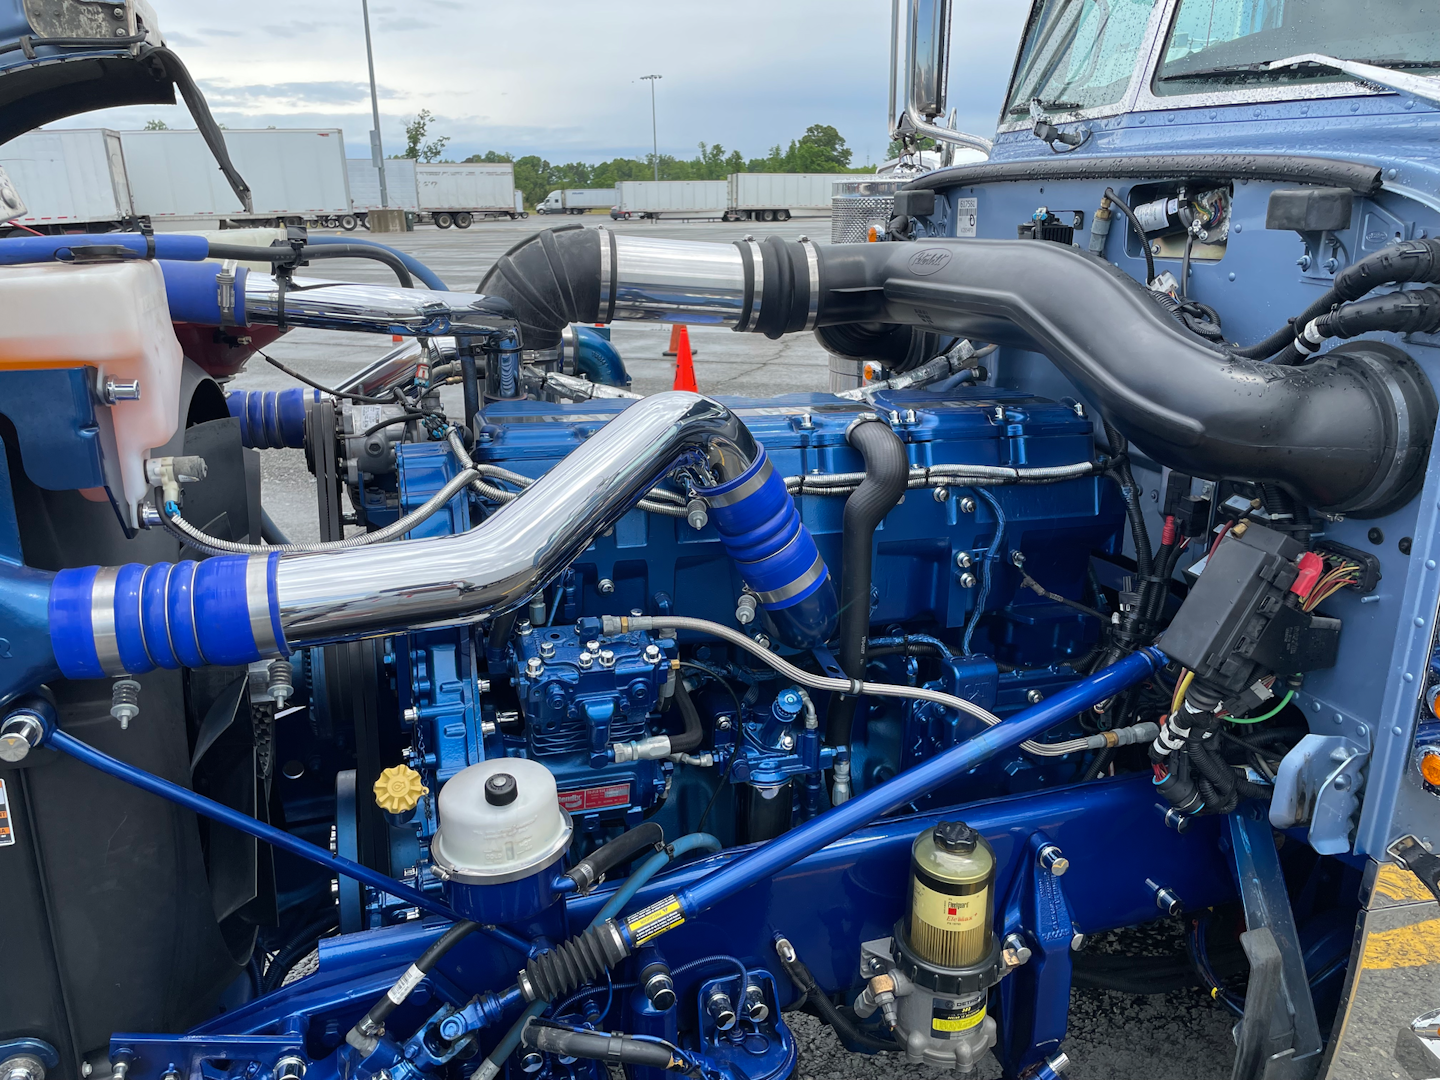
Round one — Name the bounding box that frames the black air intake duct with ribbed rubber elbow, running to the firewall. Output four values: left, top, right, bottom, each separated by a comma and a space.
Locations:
481, 229, 1436, 517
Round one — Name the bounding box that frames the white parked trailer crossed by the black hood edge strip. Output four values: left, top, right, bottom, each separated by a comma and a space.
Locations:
120, 128, 350, 232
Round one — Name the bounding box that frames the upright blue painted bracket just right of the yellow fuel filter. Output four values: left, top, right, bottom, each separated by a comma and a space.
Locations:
996, 832, 1076, 1076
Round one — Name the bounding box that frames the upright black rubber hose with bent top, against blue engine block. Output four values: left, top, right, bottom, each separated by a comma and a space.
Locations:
825, 418, 910, 747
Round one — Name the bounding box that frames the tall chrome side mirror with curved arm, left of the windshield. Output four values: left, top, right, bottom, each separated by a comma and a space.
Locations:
890, 0, 991, 154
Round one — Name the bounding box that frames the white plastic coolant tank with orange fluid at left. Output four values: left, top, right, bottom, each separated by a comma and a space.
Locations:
0, 259, 184, 524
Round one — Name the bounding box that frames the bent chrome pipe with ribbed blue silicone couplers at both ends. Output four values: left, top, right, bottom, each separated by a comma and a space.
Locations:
49, 392, 837, 678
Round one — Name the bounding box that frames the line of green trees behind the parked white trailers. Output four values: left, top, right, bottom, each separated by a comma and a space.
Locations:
402, 109, 870, 206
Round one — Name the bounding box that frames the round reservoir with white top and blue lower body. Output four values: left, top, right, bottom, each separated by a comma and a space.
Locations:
431, 757, 572, 923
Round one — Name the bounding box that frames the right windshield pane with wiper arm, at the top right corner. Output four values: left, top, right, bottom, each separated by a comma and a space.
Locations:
1155, 0, 1440, 95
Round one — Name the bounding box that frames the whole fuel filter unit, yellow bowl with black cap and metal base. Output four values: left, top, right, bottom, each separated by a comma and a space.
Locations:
855, 821, 1012, 1073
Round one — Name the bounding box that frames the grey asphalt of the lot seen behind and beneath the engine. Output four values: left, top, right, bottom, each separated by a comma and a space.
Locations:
232, 215, 1234, 1080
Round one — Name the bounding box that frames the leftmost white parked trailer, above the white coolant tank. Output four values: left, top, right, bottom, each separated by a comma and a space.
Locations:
0, 128, 133, 233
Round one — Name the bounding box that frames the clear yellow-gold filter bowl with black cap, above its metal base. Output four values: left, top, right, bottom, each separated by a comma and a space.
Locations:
906, 821, 995, 968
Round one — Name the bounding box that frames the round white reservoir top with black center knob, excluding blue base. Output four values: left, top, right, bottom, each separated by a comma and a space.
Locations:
431, 757, 570, 883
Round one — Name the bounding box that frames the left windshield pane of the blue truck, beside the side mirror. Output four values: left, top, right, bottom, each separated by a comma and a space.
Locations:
1002, 0, 1152, 122
